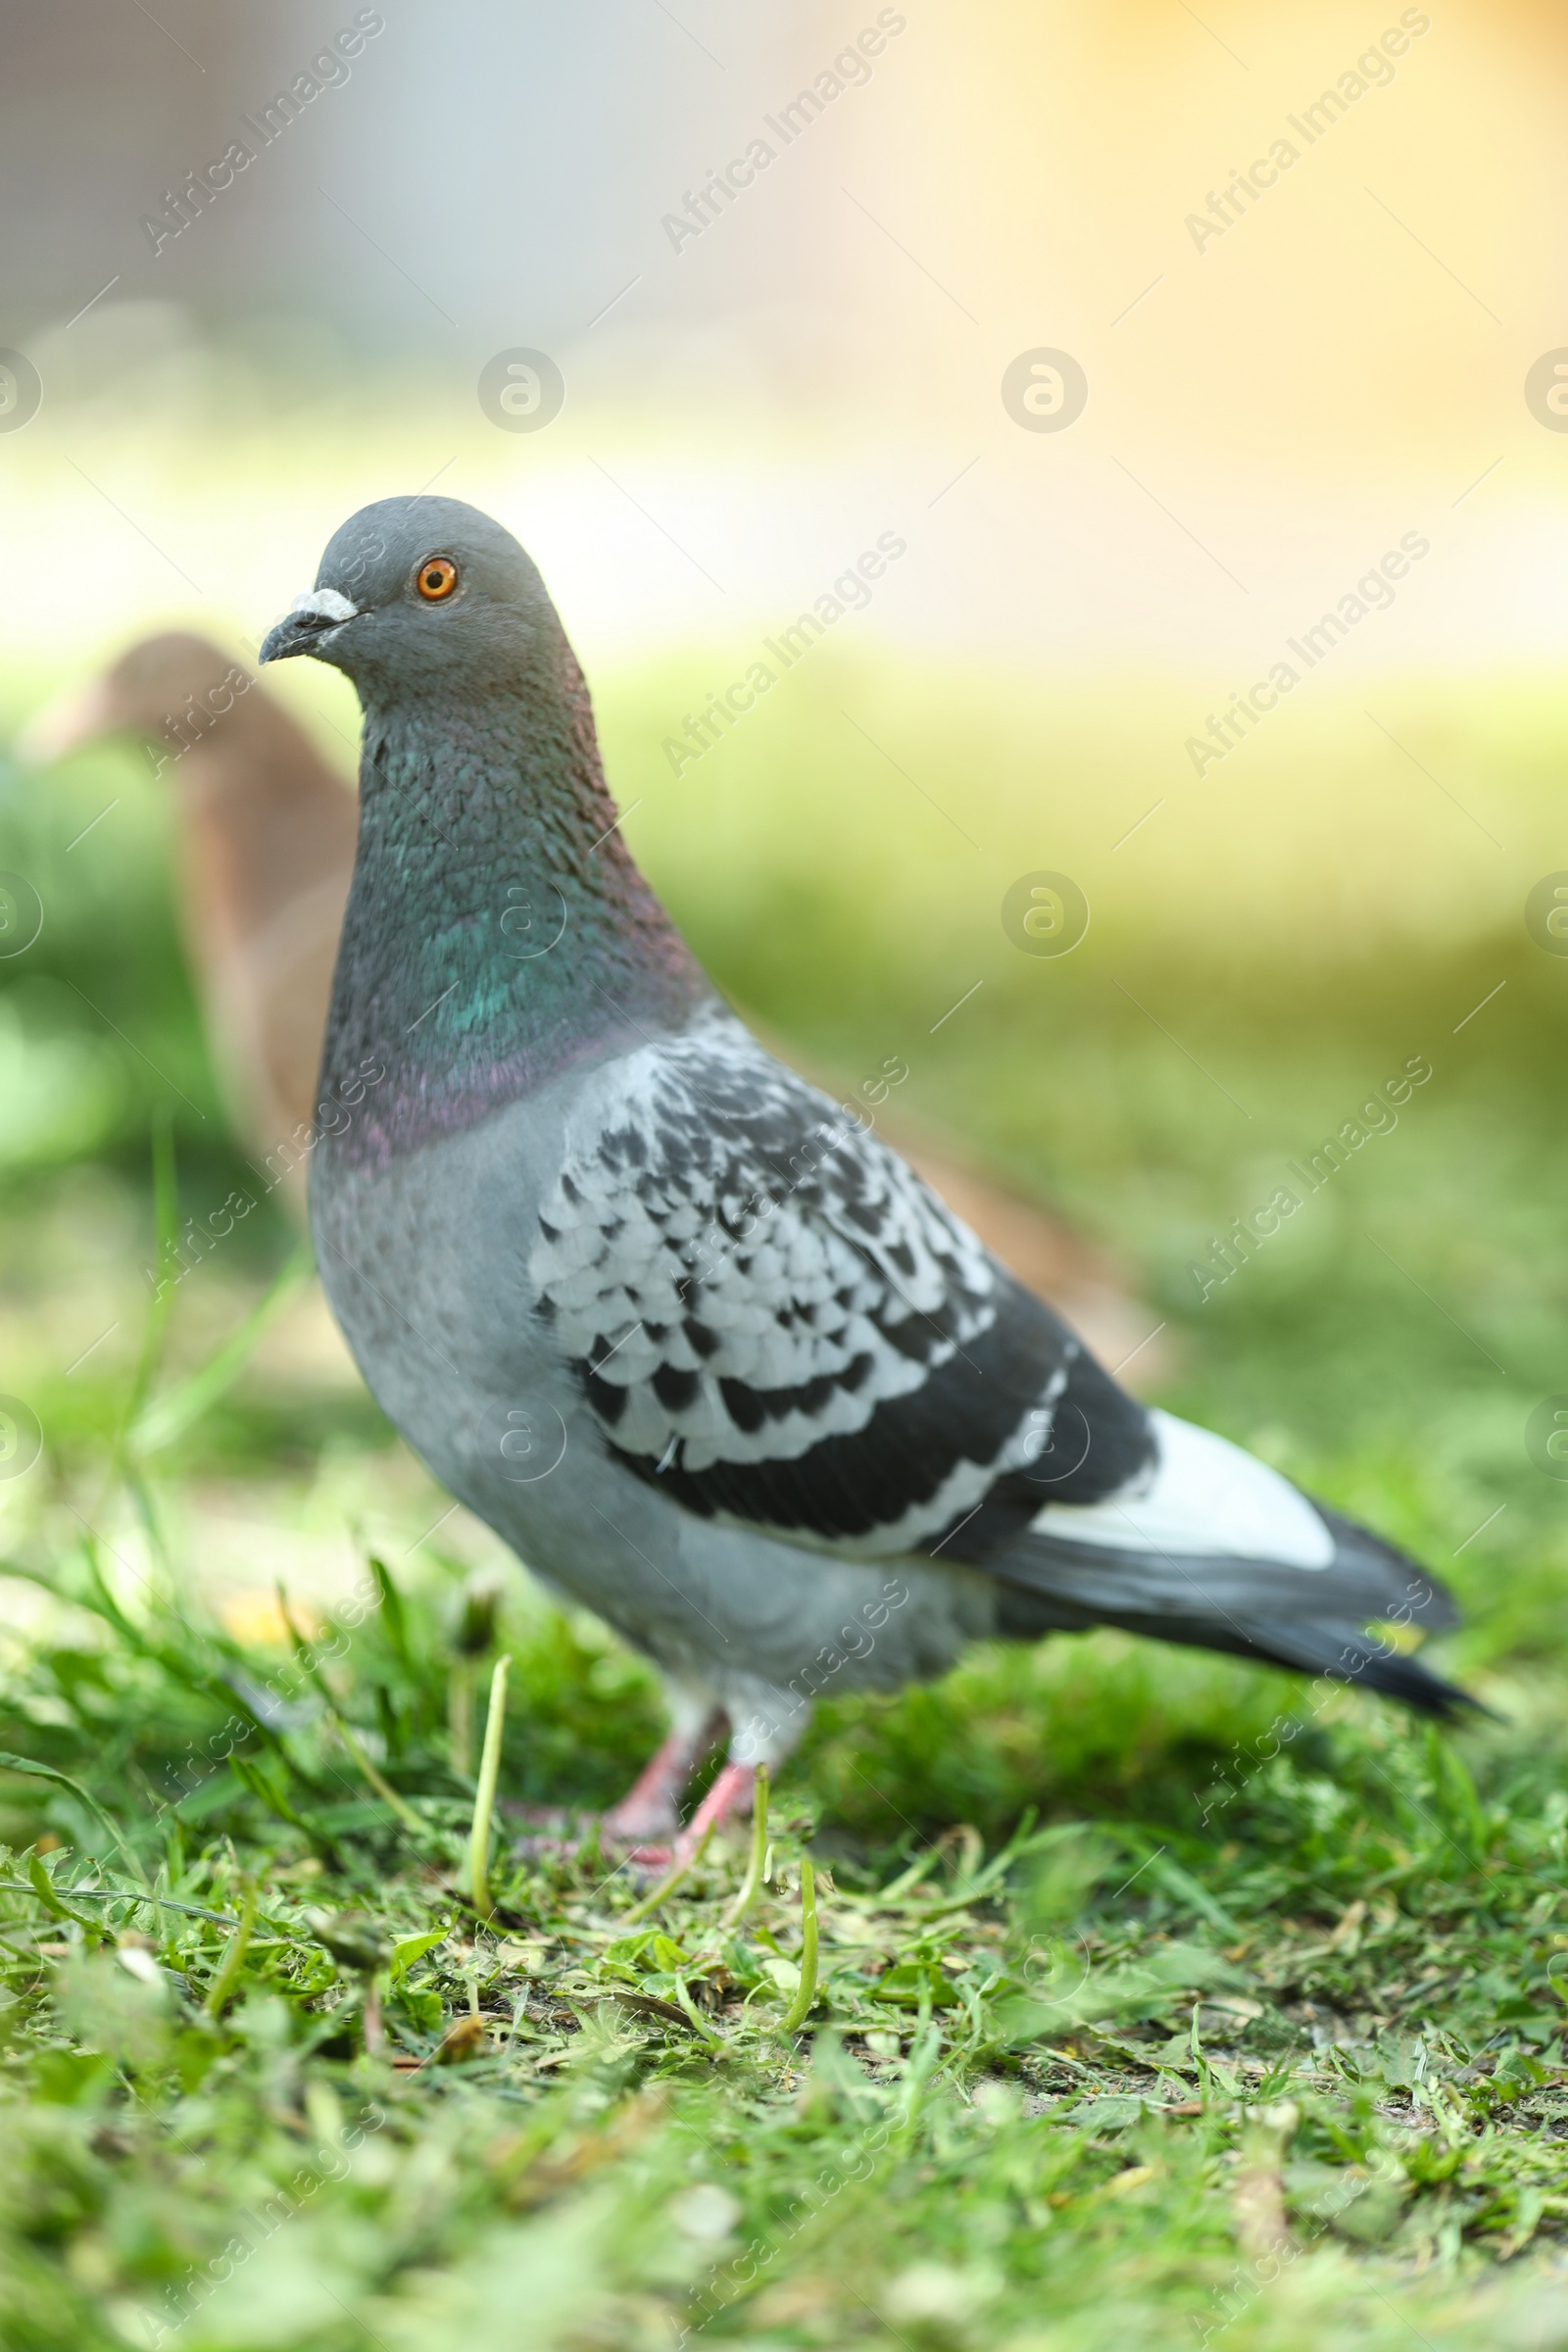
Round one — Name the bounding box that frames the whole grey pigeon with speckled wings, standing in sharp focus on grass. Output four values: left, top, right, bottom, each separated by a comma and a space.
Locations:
261, 496, 1462, 1844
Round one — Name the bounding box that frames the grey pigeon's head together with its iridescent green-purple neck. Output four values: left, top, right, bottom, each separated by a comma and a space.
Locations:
261, 496, 712, 1133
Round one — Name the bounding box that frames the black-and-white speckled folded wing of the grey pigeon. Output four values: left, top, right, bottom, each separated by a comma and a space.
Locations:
531, 1021, 1152, 1559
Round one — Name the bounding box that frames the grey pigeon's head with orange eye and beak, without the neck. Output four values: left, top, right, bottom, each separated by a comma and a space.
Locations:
261, 496, 562, 704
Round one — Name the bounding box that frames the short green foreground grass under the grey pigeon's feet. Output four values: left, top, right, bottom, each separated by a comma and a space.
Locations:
0, 1547, 1568, 2352
